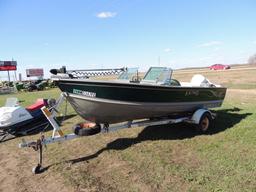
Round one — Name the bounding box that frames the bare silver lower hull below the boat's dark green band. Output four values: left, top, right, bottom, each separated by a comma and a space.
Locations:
67, 94, 222, 124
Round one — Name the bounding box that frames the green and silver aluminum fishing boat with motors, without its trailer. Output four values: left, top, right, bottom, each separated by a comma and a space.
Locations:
51, 67, 226, 124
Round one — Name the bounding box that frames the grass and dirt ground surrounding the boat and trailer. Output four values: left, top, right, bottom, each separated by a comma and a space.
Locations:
0, 65, 256, 192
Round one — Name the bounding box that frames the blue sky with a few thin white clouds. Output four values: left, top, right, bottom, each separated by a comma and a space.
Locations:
0, 0, 256, 77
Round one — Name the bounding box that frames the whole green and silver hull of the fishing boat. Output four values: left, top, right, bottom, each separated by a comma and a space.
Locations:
57, 80, 226, 124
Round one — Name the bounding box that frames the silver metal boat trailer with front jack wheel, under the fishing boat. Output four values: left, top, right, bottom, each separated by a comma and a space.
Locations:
19, 93, 216, 174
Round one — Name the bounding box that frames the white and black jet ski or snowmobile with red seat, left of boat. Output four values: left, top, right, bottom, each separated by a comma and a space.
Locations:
0, 98, 54, 141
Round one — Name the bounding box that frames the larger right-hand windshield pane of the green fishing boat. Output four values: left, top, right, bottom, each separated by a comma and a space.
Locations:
143, 67, 172, 82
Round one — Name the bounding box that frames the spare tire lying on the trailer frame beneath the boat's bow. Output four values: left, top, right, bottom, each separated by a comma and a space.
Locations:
73, 122, 101, 136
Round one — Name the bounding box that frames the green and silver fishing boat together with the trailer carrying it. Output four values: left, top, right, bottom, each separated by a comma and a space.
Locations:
19, 67, 226, 174
